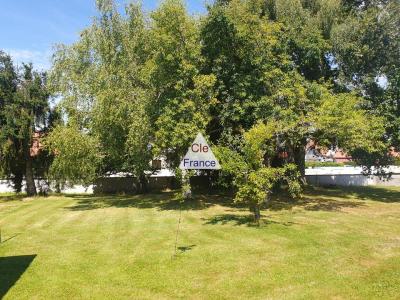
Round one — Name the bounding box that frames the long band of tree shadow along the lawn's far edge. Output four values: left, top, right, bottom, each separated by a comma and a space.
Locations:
66, 187, 400, 213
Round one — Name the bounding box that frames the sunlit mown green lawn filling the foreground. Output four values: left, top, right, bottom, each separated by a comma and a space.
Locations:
0, 187, 400, 299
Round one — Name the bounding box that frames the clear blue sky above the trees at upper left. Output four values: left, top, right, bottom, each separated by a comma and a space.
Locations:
0, 0, 211, 70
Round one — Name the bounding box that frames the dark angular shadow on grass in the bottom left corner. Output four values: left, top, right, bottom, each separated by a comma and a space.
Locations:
0, 254, 36, 299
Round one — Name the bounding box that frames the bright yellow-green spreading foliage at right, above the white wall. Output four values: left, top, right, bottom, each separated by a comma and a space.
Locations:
314, 93, 389, 168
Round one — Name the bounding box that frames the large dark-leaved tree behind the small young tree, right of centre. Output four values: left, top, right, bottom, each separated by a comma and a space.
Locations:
202, 0, 386, 179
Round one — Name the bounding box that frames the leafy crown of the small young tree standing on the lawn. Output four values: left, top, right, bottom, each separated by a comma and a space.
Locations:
214, 123, 302, 222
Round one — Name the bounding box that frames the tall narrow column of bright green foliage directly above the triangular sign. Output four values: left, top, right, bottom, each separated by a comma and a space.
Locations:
150, 1, 215, 167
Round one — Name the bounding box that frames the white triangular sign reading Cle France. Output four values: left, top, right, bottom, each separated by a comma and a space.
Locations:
179, 133, 221, 170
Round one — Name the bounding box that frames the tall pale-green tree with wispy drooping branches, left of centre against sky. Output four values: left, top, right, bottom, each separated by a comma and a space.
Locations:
49, 1, 154, 188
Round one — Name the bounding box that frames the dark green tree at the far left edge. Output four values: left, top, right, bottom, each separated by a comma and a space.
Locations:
0, 52, 51, 196
